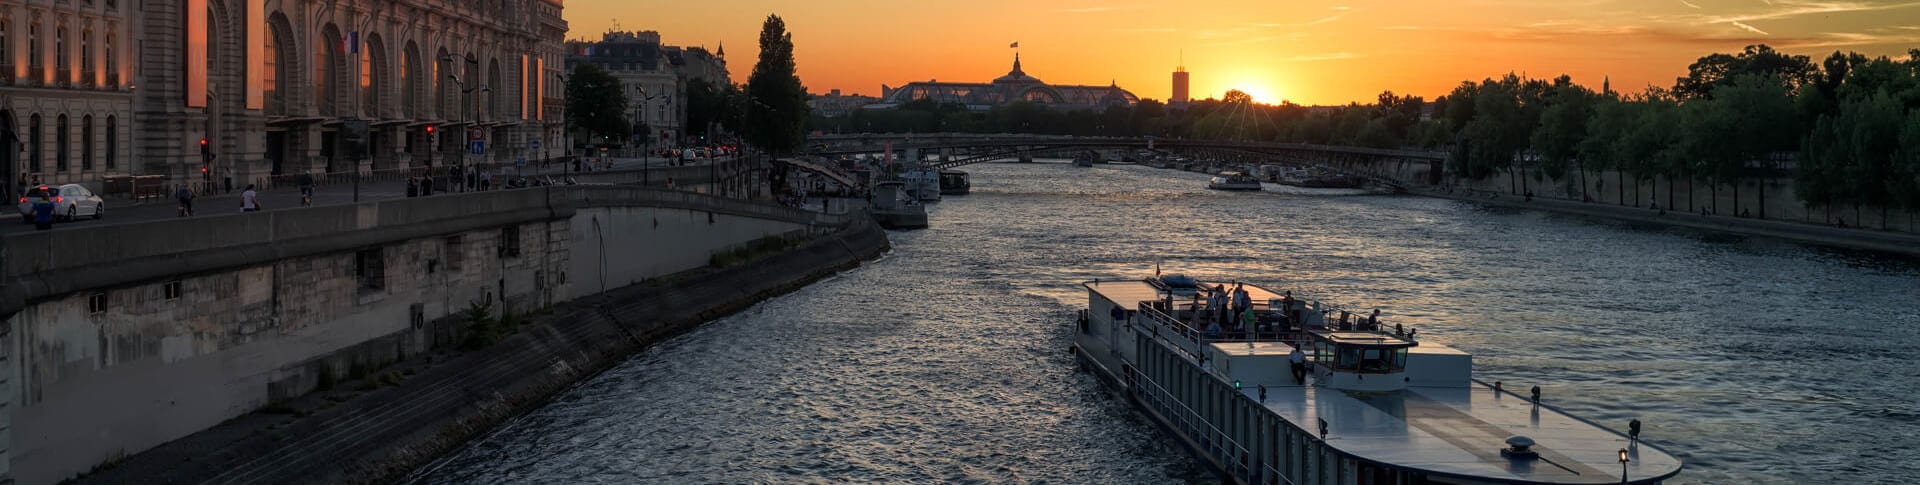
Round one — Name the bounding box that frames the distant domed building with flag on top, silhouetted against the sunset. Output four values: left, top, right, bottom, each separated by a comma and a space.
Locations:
868, 54, 1140, 111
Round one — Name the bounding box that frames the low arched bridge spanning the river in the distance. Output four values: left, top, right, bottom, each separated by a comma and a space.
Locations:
806, 134, 1446, 190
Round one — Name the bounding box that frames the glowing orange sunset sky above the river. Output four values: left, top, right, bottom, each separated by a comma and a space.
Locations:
564, 0, 1920, 104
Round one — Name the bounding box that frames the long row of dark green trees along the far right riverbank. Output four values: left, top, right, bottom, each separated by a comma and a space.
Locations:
812, 46, 1920, 228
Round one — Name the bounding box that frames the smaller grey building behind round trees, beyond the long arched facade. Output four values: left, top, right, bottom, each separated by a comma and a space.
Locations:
566, 31, 732, 146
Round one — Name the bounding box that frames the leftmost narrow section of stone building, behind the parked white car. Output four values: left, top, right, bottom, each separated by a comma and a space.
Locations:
0, 0, 138, 197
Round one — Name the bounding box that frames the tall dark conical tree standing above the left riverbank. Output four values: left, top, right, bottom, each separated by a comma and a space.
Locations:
745, 15, 808, 157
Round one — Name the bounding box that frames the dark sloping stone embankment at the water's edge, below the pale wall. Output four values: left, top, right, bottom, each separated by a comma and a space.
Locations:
81, 220, 889, 483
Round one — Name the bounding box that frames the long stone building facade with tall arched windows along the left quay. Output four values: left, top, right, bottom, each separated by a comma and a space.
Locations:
0, 0, 566, 197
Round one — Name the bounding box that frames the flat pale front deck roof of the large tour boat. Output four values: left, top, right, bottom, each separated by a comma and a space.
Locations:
1240, 381, 1680, 483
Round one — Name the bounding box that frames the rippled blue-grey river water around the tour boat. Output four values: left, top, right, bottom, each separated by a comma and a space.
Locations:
420, 163, 1920, 483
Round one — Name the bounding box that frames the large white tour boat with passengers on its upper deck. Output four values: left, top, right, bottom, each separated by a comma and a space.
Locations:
1069, 276, 1682, 485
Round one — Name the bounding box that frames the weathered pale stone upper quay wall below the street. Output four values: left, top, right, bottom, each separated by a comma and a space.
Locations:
0, 186, 847, 483
